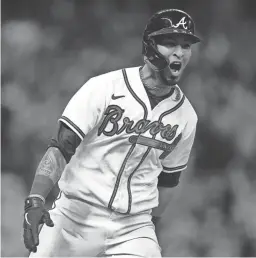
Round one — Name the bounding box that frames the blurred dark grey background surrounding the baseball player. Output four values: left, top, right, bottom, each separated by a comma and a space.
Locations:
1, 0, 256, 257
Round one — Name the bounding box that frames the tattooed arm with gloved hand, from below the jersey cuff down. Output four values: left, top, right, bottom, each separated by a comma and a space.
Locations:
23, 122, 81, 252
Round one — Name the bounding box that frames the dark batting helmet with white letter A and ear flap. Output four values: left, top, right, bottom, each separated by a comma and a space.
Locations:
142, 9, 200, 70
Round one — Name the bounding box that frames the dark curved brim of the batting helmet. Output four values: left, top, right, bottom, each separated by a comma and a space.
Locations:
148, 28, 201, 44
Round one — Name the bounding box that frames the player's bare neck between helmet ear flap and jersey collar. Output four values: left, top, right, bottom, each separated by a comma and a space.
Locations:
141, 64, 174, 96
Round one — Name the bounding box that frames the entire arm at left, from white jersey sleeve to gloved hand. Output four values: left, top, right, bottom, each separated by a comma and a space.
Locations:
24, 78, 111, 252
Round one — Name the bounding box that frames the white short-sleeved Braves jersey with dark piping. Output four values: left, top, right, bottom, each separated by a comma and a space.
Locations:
59, 67, 197, 214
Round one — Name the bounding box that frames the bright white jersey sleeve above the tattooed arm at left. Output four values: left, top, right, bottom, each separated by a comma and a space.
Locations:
59, 78, 106, 140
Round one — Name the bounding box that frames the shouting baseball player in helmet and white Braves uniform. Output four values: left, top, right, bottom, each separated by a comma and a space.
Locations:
24, 9, 200, 257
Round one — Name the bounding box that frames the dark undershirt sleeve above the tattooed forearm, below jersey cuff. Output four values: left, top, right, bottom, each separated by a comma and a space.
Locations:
48, 122, 81, 163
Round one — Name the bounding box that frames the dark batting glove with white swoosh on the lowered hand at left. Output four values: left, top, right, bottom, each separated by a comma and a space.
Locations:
23, 197, 54, 253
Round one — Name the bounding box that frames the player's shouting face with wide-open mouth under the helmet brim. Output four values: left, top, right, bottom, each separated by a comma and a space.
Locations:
157, 36, 191, 83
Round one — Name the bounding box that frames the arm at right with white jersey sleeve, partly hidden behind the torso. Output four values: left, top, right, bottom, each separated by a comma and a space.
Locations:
152, 120, 197, 225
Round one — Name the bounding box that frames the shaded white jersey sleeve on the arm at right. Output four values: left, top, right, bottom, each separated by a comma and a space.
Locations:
162, 117, 197, 173
